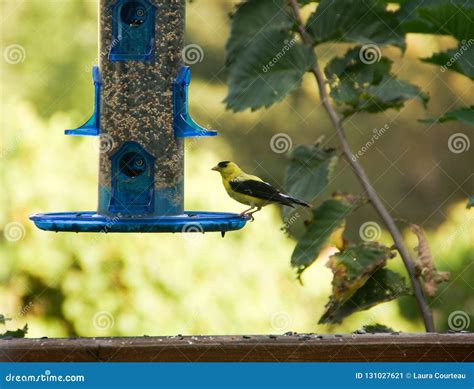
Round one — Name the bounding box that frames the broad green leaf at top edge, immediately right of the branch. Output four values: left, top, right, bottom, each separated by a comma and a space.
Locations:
306, 0, 405, 50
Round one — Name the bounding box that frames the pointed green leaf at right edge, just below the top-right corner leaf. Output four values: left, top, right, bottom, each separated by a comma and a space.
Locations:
421, 45, 474, 80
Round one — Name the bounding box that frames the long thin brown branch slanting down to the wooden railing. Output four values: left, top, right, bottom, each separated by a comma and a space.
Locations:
288, 0, 435, 332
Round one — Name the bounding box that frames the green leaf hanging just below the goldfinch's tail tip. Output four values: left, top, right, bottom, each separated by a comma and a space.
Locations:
291, 198, 357, 277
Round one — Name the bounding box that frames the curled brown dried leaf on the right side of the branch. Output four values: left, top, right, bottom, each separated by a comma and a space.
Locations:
410, 223, 450, 297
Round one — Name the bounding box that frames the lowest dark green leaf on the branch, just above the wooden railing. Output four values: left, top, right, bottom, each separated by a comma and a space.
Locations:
319, 268, 410, 324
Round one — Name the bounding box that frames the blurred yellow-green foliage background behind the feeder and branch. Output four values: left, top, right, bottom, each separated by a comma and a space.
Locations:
0, 0, 474, 337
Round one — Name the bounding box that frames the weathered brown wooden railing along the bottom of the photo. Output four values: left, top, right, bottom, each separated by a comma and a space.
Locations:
0, 334, 474, 362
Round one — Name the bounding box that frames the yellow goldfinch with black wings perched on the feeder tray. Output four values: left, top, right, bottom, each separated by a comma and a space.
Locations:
212, 161, 310, 220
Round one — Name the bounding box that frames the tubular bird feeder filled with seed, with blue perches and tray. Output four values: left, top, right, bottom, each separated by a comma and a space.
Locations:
30, 0, 247, 234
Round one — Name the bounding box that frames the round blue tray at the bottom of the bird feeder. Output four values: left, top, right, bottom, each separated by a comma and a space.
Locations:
30, 211, 248, 236
